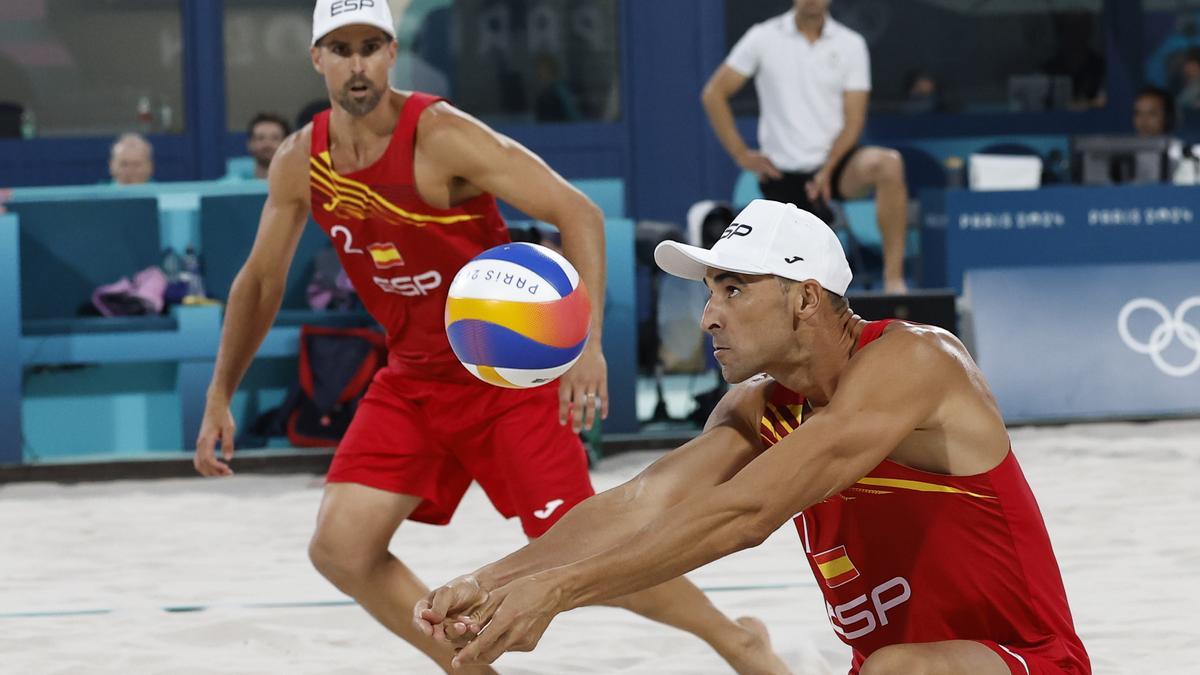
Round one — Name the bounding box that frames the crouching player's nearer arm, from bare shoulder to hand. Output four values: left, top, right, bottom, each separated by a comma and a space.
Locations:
458, 330, 965, 664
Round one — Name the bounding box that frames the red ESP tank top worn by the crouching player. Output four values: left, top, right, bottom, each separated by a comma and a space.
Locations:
760, 321, 1090, 674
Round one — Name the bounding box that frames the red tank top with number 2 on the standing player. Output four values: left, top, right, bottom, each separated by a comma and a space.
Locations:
308, 92, 510, 382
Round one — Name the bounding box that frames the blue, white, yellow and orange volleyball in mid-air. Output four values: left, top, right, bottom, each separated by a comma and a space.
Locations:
445, 244, 592, 389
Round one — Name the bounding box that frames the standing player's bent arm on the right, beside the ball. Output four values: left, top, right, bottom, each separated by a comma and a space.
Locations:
414, 103, 608, 430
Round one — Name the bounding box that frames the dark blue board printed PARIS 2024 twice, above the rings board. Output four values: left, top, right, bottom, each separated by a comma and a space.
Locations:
925, 185, 1200, 291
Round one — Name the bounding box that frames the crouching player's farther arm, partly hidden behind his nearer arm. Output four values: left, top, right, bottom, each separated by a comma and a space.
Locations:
414, 378, 769, 638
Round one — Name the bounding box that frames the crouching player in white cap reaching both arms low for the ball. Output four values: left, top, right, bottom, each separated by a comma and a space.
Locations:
414, 199, 1090, 675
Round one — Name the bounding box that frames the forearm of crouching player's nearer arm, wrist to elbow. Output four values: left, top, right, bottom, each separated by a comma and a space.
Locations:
547, 488, 766, 610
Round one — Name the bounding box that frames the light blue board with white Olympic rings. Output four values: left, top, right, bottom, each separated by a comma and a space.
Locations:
965, 263, 1200, 422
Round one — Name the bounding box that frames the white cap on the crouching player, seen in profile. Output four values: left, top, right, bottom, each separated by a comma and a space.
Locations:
654, 199, 852, 295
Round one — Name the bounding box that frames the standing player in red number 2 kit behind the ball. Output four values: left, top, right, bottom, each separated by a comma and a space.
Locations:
194, 0, 784, 673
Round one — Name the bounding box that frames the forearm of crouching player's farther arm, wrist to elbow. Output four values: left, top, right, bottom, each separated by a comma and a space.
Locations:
475, 482, 661, 590
